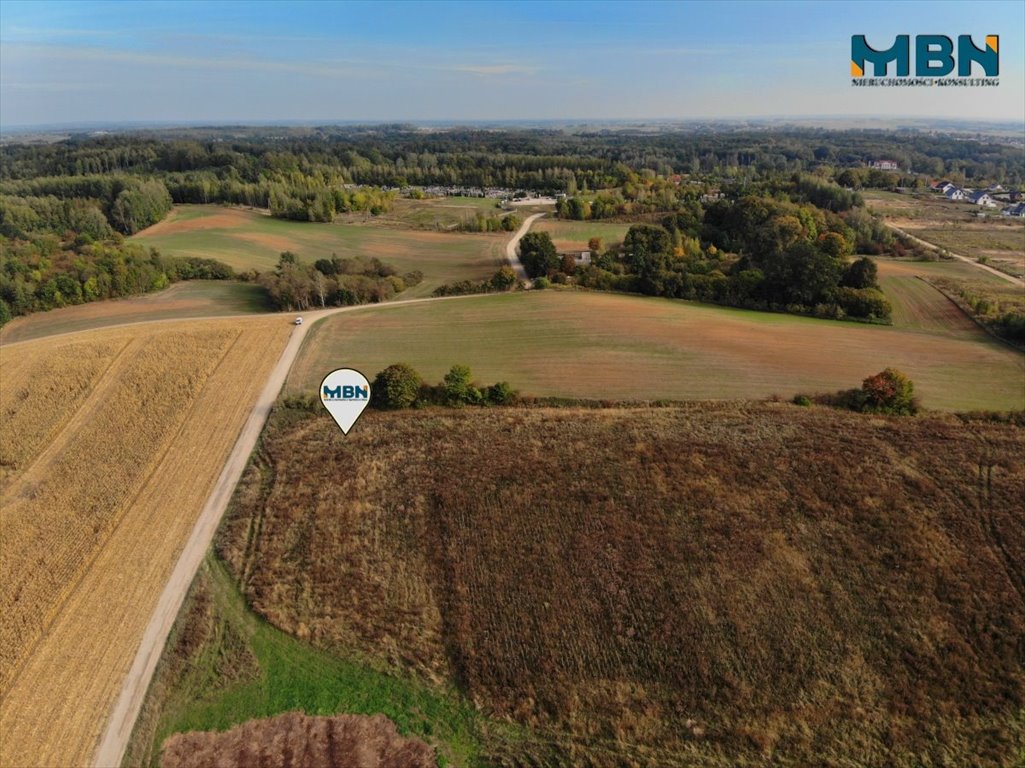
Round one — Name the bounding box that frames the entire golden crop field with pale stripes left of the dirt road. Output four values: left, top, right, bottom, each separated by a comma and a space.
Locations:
0, 318, 290, 766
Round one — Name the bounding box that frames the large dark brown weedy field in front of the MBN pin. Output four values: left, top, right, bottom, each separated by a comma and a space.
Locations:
216, 403, 1025, 767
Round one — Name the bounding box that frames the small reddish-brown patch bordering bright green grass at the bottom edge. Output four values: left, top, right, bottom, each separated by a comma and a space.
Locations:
160, 712, 438, 768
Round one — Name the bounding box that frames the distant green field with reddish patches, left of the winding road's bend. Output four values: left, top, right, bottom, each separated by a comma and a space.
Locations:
132, 205, 508, 297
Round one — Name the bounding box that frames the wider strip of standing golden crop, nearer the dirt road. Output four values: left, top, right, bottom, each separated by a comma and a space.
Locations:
0, 331, 235, 686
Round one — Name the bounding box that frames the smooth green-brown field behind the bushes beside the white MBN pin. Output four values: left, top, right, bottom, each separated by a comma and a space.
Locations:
286, 291, 1025, 410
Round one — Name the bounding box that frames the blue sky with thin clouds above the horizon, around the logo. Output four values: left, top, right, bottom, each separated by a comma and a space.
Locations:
0, 0, 1025, 126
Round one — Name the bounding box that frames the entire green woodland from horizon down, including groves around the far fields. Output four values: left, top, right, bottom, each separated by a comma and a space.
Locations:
0, 126, 1025, 336
